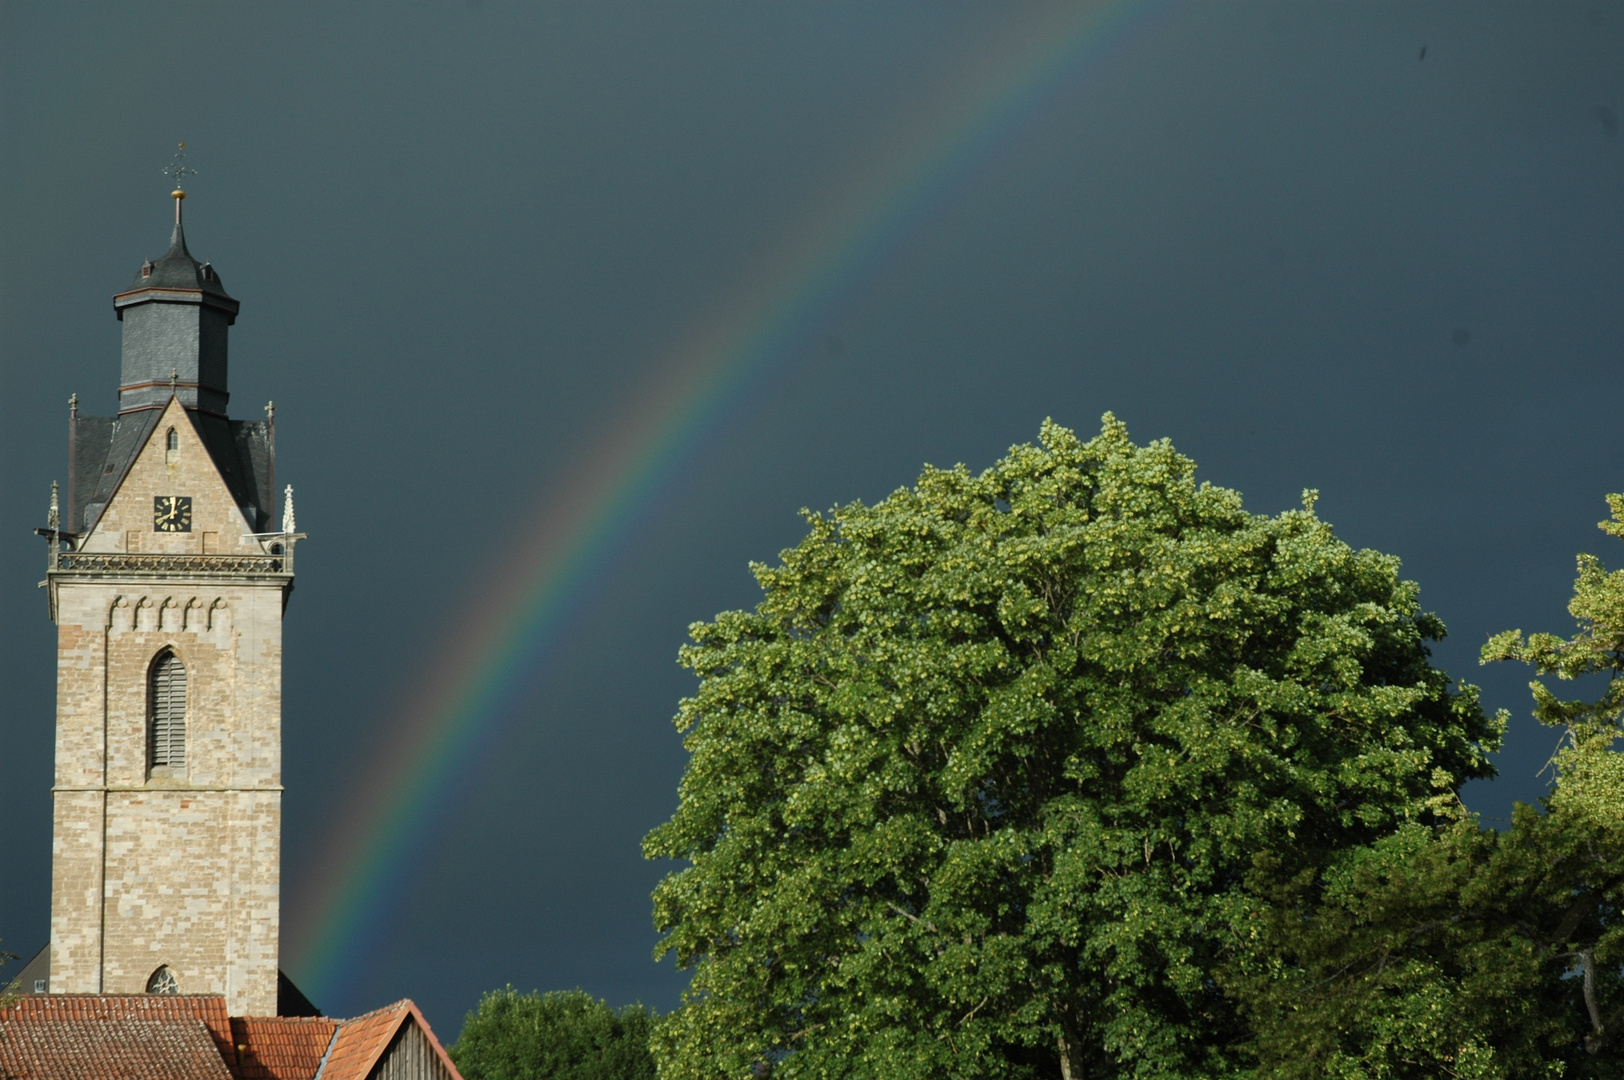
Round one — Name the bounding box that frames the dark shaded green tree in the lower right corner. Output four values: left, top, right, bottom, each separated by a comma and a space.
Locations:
1224, 805, 1624, 1080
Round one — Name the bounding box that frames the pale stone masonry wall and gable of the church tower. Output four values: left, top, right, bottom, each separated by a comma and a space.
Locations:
50, 397, 284, 1015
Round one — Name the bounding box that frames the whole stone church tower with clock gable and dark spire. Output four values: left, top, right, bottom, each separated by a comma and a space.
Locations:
44, 167, 300, 1017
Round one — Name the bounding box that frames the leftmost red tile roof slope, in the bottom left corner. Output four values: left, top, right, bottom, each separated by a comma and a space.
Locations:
0, 1018, 231, 1080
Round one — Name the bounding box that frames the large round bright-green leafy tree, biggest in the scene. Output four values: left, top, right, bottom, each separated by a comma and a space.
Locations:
645, 414, 1497, 1080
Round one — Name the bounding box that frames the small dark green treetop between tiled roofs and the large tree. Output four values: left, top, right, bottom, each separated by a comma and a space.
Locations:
448, 986, 654, 1080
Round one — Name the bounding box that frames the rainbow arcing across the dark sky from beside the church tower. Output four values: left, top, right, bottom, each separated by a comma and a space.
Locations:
284, 0, 1161, 1007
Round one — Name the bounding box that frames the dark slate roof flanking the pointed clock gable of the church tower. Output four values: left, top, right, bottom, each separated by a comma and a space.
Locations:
63, 409, 276, 536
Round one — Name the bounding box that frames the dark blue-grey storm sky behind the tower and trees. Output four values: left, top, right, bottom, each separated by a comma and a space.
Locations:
0, 0, 1624, 1038
